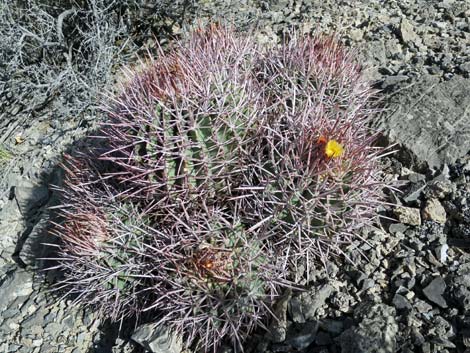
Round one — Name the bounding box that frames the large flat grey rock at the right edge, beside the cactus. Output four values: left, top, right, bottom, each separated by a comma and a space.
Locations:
381, 75, 470, 168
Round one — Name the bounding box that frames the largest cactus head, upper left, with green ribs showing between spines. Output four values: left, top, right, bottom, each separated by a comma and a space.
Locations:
101, 27, 257, 208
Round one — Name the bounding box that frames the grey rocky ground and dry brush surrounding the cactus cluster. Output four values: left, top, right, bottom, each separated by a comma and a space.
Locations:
0, 0, 470, 353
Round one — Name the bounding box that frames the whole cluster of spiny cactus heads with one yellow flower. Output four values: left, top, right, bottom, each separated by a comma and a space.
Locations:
49, 25, 392, 351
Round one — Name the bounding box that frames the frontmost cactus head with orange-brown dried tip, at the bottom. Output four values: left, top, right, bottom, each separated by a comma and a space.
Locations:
142, 210, 282, 351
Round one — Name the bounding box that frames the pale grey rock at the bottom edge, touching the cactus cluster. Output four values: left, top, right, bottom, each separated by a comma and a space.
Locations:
131, 324, 183, 353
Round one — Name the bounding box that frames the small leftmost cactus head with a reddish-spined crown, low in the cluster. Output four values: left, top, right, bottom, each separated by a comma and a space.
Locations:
51, 156, 155, 321
